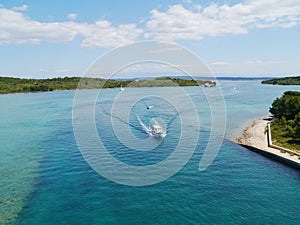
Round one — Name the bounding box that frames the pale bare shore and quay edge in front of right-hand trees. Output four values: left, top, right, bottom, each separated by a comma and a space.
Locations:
235, 116, 300, 169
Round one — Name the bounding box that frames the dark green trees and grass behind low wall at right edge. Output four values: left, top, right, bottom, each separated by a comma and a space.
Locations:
270, 91, 300, 150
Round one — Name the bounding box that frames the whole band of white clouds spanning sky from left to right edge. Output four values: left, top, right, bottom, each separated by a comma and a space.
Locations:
0, 0, 300, 47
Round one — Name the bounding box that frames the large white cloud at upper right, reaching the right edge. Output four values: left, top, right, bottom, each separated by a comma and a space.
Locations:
145, 0, 300, 41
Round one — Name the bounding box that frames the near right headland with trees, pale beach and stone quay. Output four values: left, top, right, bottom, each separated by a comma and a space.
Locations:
236, 91, 300, 169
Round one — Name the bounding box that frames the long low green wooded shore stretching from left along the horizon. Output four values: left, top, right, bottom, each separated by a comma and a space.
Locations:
0, 77, 216, 94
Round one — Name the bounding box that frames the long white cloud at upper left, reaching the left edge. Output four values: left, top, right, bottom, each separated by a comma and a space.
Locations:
0, 7, 142, 47
